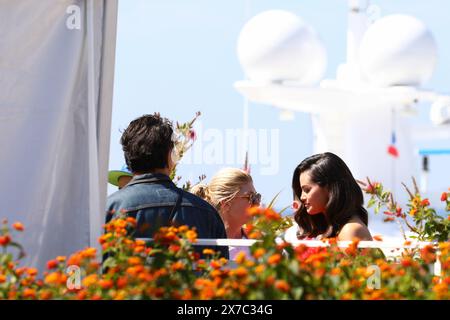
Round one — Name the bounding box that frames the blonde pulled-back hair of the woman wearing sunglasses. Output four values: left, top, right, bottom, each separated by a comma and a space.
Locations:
190, 168, 253, 211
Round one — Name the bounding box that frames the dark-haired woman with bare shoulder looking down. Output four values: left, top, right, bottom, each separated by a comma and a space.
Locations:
292, 152, 372, 241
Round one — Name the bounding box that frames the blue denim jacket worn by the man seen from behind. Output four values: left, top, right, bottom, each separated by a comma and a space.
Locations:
106, 173, 228, 258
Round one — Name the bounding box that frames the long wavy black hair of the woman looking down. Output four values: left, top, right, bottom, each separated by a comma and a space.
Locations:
292, 152, 368, 239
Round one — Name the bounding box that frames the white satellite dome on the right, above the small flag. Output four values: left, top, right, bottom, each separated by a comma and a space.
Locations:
360, 14, 437, 86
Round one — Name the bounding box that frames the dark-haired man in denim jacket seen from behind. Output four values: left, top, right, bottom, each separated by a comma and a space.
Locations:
106, 113, 228, 258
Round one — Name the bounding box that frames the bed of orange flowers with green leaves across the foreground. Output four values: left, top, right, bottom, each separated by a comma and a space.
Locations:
0, 201, 450, 299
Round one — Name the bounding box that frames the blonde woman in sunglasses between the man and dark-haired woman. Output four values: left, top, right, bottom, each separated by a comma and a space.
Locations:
191, 168, 261, 260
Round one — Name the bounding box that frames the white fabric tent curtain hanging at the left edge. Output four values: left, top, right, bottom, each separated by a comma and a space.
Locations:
0, 0, 117, 267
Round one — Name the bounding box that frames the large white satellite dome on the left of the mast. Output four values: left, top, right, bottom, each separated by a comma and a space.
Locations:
237, 10, 327, 85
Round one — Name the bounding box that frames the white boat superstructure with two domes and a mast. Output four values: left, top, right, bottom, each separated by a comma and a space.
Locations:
234, 0, 450, 199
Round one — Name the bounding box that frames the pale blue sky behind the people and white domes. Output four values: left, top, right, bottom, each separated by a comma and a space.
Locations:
108, 0, 450, 234
